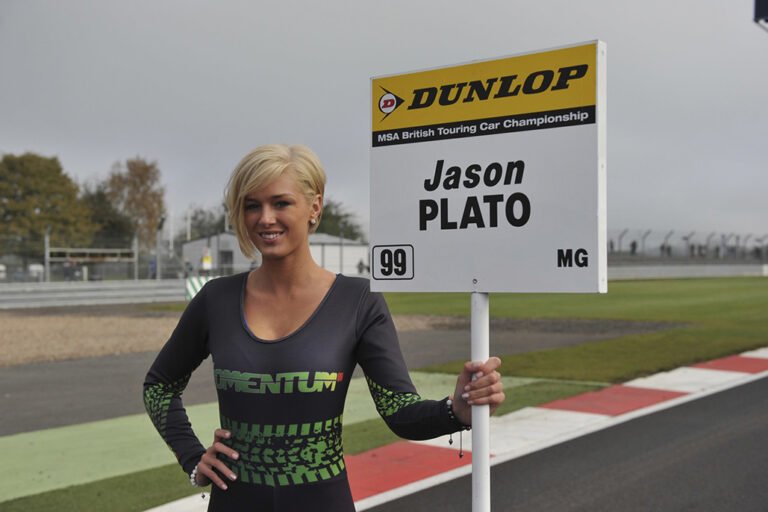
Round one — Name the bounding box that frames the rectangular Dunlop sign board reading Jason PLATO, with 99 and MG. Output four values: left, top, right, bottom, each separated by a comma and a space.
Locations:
371, 41, 607, 292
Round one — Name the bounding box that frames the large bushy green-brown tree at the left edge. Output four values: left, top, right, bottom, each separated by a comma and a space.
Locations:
0, 153, 95, 266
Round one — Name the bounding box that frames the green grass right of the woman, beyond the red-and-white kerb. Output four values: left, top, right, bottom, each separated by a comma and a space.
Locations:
412, 278, 768, 382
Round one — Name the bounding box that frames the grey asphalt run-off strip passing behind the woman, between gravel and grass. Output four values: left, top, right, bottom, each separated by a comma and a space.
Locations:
0, 322, 660, 436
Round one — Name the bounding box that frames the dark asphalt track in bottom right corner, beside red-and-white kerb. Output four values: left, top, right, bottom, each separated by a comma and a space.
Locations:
369, 378, 768, 512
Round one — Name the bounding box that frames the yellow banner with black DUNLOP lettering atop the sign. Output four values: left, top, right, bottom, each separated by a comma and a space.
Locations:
371, 41, 597, 132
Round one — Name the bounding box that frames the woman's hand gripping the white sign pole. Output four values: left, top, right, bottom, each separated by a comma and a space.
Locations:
452, 357, 504, 425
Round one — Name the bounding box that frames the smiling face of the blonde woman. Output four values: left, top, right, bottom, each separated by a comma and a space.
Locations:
243, 171, 322, 259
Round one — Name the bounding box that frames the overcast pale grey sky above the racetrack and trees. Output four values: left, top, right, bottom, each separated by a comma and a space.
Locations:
0, 0, 768, 244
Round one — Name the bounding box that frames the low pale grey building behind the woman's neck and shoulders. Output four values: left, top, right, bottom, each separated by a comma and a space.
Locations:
181, 231, 370, 275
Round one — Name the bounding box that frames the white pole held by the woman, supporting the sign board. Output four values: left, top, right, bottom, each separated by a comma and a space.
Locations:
470, 292, 491, 512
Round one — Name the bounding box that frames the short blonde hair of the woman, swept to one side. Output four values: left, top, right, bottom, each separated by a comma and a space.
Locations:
225, 144, 326, 259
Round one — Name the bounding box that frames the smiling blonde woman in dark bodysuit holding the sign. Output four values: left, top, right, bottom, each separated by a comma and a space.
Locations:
144, 145, 504, 512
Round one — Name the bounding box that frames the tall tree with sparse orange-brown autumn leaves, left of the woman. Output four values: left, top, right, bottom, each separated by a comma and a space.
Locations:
106, 156, 165, 249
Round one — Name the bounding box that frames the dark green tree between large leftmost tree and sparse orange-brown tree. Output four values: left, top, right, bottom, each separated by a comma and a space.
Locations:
81, 182, 134, 248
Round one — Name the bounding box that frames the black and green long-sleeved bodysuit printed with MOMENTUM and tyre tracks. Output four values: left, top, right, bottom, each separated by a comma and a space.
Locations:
144, 273, 460, 512
